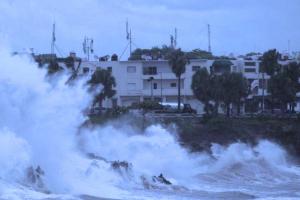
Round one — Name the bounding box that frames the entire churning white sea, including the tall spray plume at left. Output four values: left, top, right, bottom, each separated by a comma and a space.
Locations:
0, 48, 300, 199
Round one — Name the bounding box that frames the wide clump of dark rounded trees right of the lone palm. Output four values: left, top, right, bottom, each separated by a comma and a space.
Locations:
191, 68, 248, 116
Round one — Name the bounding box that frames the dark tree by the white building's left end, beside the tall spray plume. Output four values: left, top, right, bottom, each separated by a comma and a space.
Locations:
88, 69, 116, 107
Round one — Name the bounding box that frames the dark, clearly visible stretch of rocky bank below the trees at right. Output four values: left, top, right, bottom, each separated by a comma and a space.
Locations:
166, 118, 300, 160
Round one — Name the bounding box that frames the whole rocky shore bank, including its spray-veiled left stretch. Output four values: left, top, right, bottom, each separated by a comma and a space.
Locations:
85, 115, 300, 161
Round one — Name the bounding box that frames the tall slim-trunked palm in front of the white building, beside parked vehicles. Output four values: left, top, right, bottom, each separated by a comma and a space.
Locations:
168, 48, 189, 110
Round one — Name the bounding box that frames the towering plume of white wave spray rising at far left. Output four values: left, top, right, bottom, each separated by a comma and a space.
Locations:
0, 46, 126, 196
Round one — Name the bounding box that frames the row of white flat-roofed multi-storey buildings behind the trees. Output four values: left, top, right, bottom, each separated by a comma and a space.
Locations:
67, 55, 300, 113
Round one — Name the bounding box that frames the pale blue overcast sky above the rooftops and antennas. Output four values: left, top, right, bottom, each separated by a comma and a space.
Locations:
0, 0, 300, 59
